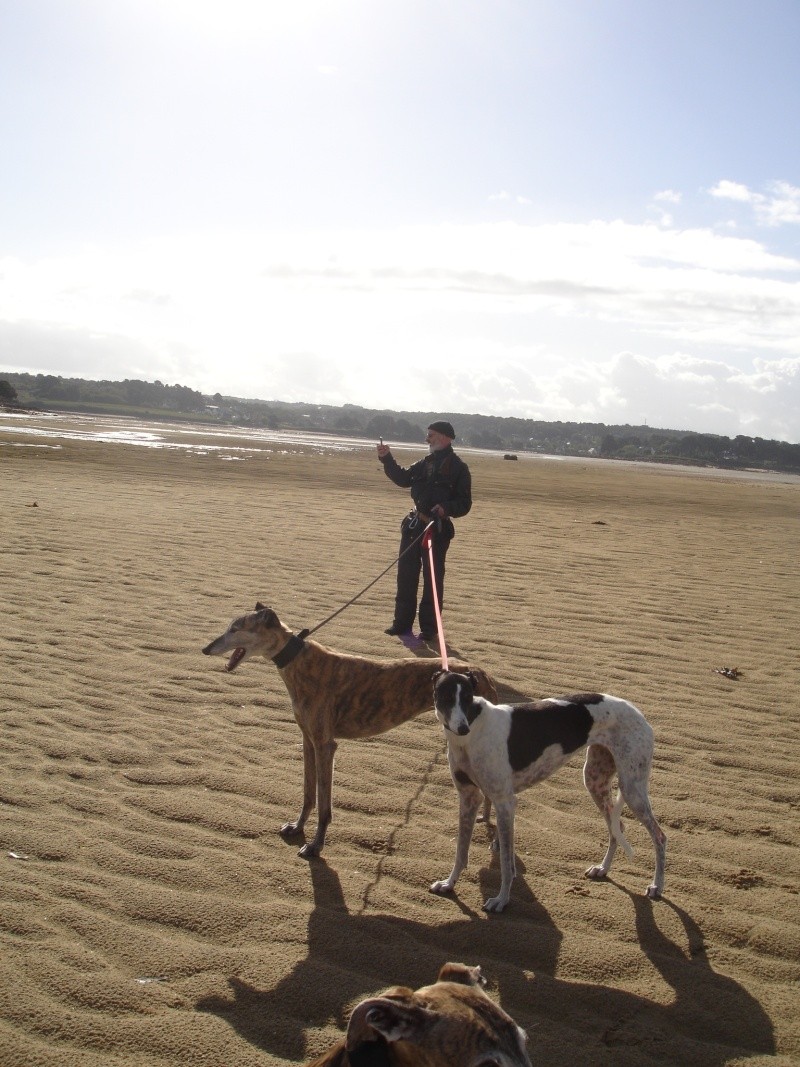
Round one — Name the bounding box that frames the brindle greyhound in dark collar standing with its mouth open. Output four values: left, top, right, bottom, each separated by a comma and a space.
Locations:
203, 603, 497, 859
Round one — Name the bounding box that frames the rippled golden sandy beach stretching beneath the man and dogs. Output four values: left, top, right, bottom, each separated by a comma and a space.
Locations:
0, 411, 800, 1067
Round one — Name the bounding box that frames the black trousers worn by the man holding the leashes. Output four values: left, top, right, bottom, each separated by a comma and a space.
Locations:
394, 512, 453, 634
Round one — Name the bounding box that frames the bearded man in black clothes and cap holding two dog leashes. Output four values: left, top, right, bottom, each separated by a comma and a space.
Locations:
378, 421, 473, 641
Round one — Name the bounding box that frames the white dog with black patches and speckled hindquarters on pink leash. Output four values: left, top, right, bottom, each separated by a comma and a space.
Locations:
431, 671, 667, 911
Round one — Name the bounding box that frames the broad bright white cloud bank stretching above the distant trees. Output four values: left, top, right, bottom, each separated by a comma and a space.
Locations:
0, 220, 800, 441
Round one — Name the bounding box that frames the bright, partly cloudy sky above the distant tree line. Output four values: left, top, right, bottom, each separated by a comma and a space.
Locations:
0, 0, 800, 443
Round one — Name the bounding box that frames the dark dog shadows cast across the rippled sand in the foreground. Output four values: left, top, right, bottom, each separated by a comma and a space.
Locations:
195, 858, 775, 1067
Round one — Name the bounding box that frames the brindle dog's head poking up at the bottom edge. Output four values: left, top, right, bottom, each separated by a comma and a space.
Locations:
308, 964, 531, 1067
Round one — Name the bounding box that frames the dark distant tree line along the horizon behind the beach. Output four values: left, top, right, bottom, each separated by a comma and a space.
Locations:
0, 373, 800, 473
